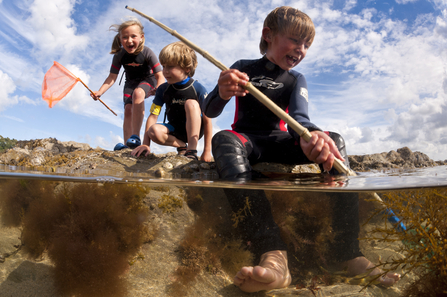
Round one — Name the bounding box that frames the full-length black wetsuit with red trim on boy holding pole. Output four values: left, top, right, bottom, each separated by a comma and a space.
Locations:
201, 57, 361, 261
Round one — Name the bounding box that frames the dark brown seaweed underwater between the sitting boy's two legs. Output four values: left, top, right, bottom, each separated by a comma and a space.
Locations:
266, 191, 335, 283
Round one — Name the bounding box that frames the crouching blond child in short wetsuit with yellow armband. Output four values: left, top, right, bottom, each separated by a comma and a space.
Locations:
132, 42, 213, 162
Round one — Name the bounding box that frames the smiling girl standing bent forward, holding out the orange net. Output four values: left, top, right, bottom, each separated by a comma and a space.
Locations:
91, 19, 164, 151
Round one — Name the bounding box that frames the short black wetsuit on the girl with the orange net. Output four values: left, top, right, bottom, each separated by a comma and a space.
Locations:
110, 46, 163, 105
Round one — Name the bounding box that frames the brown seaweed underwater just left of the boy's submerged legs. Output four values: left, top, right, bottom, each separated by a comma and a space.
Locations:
169, 188, 253, 296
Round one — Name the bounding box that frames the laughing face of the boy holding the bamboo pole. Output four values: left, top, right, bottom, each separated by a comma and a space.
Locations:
262, 27, 310, 70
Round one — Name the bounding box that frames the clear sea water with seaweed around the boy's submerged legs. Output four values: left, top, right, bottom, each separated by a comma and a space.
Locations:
0, 166, 447, 296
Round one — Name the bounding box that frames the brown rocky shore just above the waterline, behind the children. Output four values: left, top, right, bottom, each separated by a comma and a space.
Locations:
0, 138, 447, 179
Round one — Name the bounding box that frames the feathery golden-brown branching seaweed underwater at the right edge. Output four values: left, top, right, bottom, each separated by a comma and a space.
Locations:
365, 188, 447, 296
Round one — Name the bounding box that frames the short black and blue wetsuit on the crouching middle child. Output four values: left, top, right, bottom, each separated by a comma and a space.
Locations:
151, 77, 208, 143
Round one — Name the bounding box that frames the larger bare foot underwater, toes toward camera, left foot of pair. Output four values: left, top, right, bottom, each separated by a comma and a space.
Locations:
234, 250, 292, 292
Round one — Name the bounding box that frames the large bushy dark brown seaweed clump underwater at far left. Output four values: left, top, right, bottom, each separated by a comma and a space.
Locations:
1, 180, 155, 296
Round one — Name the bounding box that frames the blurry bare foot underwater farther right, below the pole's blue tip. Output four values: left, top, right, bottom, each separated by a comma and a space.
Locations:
343, 257, 400, 287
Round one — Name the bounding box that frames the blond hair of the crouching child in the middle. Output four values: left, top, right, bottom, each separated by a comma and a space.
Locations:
158, 41, 197, 77
